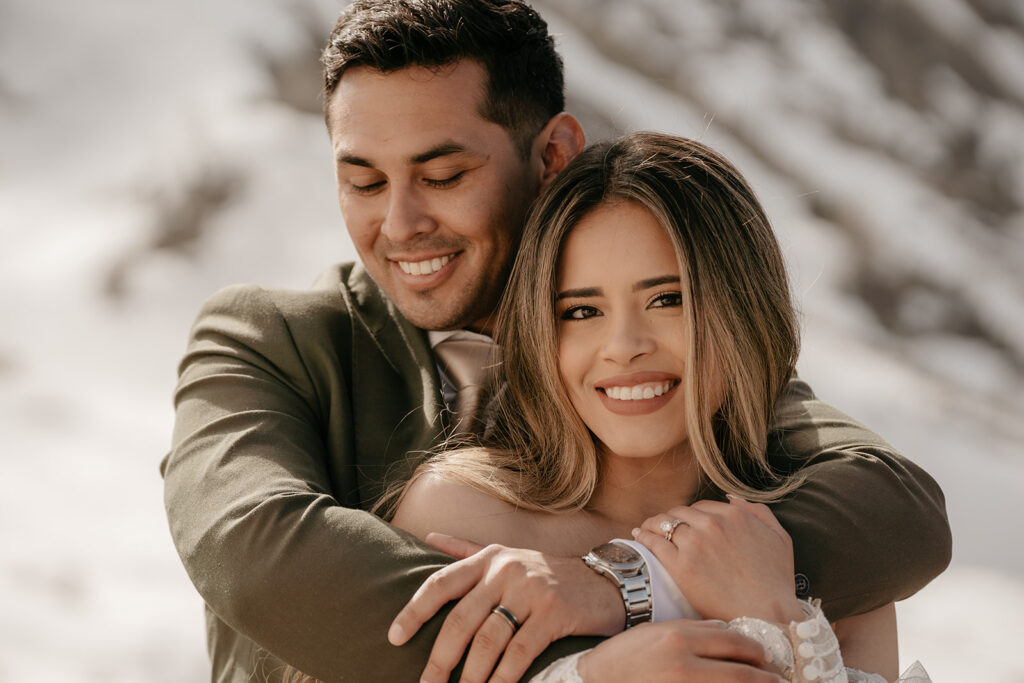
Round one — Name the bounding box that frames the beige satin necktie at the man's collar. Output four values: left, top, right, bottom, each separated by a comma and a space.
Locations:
434, 339, 502, 434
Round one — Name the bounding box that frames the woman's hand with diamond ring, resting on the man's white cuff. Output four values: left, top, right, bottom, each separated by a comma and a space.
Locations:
634, 498, 803, 624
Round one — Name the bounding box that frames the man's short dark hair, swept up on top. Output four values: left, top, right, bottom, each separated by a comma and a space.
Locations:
321, 0, 565, 157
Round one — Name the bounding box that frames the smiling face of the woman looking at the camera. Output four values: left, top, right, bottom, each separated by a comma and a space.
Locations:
555, 201, 689, 458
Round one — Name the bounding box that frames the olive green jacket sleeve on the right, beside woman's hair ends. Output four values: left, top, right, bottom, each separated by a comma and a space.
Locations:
768, 378, 952, 620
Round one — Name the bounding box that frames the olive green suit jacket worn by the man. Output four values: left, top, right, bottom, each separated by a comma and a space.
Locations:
161, 263, 950, 683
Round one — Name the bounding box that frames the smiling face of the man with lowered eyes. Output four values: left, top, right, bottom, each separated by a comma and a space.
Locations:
328, 60, 541, 331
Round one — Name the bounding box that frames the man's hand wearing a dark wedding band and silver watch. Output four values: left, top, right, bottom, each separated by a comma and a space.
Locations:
388, 533, 626, 682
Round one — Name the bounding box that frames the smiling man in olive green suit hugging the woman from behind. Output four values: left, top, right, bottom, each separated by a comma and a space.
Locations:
162, 0, 949, 681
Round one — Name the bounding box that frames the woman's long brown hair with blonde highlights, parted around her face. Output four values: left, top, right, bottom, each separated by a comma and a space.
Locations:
391, 133, 800, 511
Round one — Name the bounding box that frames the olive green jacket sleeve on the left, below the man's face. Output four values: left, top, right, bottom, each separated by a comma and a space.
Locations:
162, 288, 586, 681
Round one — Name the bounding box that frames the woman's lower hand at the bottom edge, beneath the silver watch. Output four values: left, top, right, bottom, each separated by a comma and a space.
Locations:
578, 620, 782, 683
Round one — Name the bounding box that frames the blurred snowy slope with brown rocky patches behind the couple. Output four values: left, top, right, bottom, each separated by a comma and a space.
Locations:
0, 0, 1024, 683
